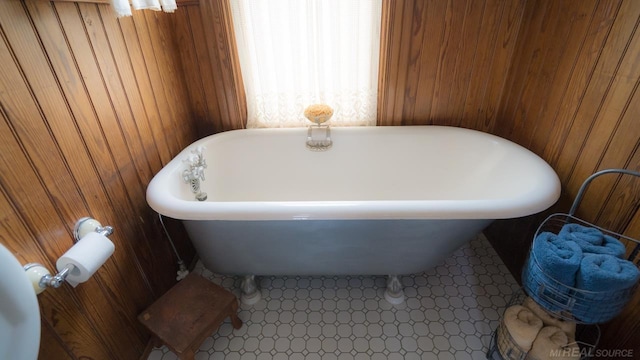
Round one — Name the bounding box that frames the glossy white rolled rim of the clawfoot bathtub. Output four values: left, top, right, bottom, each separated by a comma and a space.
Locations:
146, 125, 561, 220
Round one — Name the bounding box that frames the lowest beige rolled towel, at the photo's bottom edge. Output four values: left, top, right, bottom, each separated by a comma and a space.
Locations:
527, 326, 580, 360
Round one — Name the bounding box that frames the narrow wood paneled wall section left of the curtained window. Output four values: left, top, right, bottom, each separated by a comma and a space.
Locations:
175, 1, 247, 137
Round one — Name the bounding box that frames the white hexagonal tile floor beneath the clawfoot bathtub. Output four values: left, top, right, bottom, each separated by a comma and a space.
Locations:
148, 235, 518, 360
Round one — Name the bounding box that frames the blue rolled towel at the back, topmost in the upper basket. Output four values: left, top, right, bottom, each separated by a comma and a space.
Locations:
558, 224, 626, 258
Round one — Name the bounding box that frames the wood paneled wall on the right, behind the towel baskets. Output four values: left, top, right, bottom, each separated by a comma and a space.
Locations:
487, 0, 640, 354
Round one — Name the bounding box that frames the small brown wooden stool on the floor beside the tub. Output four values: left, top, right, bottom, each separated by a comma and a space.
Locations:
138, 273, 242, 360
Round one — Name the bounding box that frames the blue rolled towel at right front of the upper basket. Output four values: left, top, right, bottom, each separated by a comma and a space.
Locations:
576, 254, 640, 292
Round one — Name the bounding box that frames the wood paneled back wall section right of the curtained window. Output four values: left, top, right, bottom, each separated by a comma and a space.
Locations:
378, 0, 524, 131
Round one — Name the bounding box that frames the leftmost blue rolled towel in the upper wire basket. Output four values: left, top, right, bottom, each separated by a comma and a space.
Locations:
531, 232, 582, 286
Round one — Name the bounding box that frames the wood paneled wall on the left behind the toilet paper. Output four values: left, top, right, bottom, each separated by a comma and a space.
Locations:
0, 0, 197, 359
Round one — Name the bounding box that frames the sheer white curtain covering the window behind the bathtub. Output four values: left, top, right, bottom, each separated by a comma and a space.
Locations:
231, 0, 381, 127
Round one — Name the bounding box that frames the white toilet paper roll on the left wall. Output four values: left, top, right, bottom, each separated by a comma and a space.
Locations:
56, 232, 115, 287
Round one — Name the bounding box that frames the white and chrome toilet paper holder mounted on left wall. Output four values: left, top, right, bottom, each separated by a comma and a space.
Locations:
23, 217, 113, 294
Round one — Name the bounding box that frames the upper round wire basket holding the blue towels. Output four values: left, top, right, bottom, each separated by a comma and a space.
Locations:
522, 214, 640, 324
